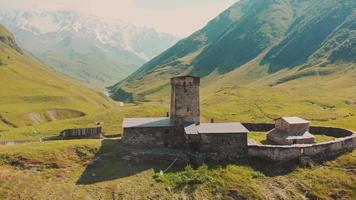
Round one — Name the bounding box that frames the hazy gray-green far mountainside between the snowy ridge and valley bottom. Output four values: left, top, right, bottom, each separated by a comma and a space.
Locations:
36, 36, 144, 88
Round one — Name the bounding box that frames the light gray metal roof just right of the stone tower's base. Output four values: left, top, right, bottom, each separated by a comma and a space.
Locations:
197, 122, 249, 134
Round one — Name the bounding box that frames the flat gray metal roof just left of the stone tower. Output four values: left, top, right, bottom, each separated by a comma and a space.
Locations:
122, 117, 174, 128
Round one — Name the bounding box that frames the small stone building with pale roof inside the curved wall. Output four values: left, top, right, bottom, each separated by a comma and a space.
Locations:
267, 117, 314, 145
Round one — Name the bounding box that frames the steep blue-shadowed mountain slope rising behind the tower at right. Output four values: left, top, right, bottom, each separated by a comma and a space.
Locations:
111, 0, 356, 100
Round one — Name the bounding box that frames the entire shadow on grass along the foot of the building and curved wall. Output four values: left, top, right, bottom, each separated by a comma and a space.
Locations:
77, 139, 348, 185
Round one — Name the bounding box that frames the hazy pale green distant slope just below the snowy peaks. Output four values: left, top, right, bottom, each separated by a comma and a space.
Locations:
37, 47, 141, 88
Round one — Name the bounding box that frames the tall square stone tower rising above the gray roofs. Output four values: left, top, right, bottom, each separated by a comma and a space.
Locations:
171, 76, 200, 124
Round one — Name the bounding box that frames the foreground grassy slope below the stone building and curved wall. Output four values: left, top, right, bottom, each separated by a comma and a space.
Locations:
0, 140, 356, 199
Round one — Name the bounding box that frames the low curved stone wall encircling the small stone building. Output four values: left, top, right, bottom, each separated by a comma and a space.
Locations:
244, 123, 356, 162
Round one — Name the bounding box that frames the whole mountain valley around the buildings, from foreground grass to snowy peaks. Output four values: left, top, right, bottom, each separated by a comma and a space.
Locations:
0, 0, 356, 200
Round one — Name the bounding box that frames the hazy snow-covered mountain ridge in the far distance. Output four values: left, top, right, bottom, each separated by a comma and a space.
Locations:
0, 10, 178, 61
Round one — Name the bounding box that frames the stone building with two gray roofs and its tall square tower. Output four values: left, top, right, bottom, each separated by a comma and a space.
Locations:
123, 76, 248, 152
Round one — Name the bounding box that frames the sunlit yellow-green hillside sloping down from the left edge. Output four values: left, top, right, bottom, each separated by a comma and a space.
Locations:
0, 25, 115, 130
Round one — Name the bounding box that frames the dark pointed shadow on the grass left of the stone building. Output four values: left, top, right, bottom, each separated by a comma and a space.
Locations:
77, 139, 162, 185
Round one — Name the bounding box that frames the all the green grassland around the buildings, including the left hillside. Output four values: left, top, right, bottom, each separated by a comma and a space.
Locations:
0, 24, 356, 200
